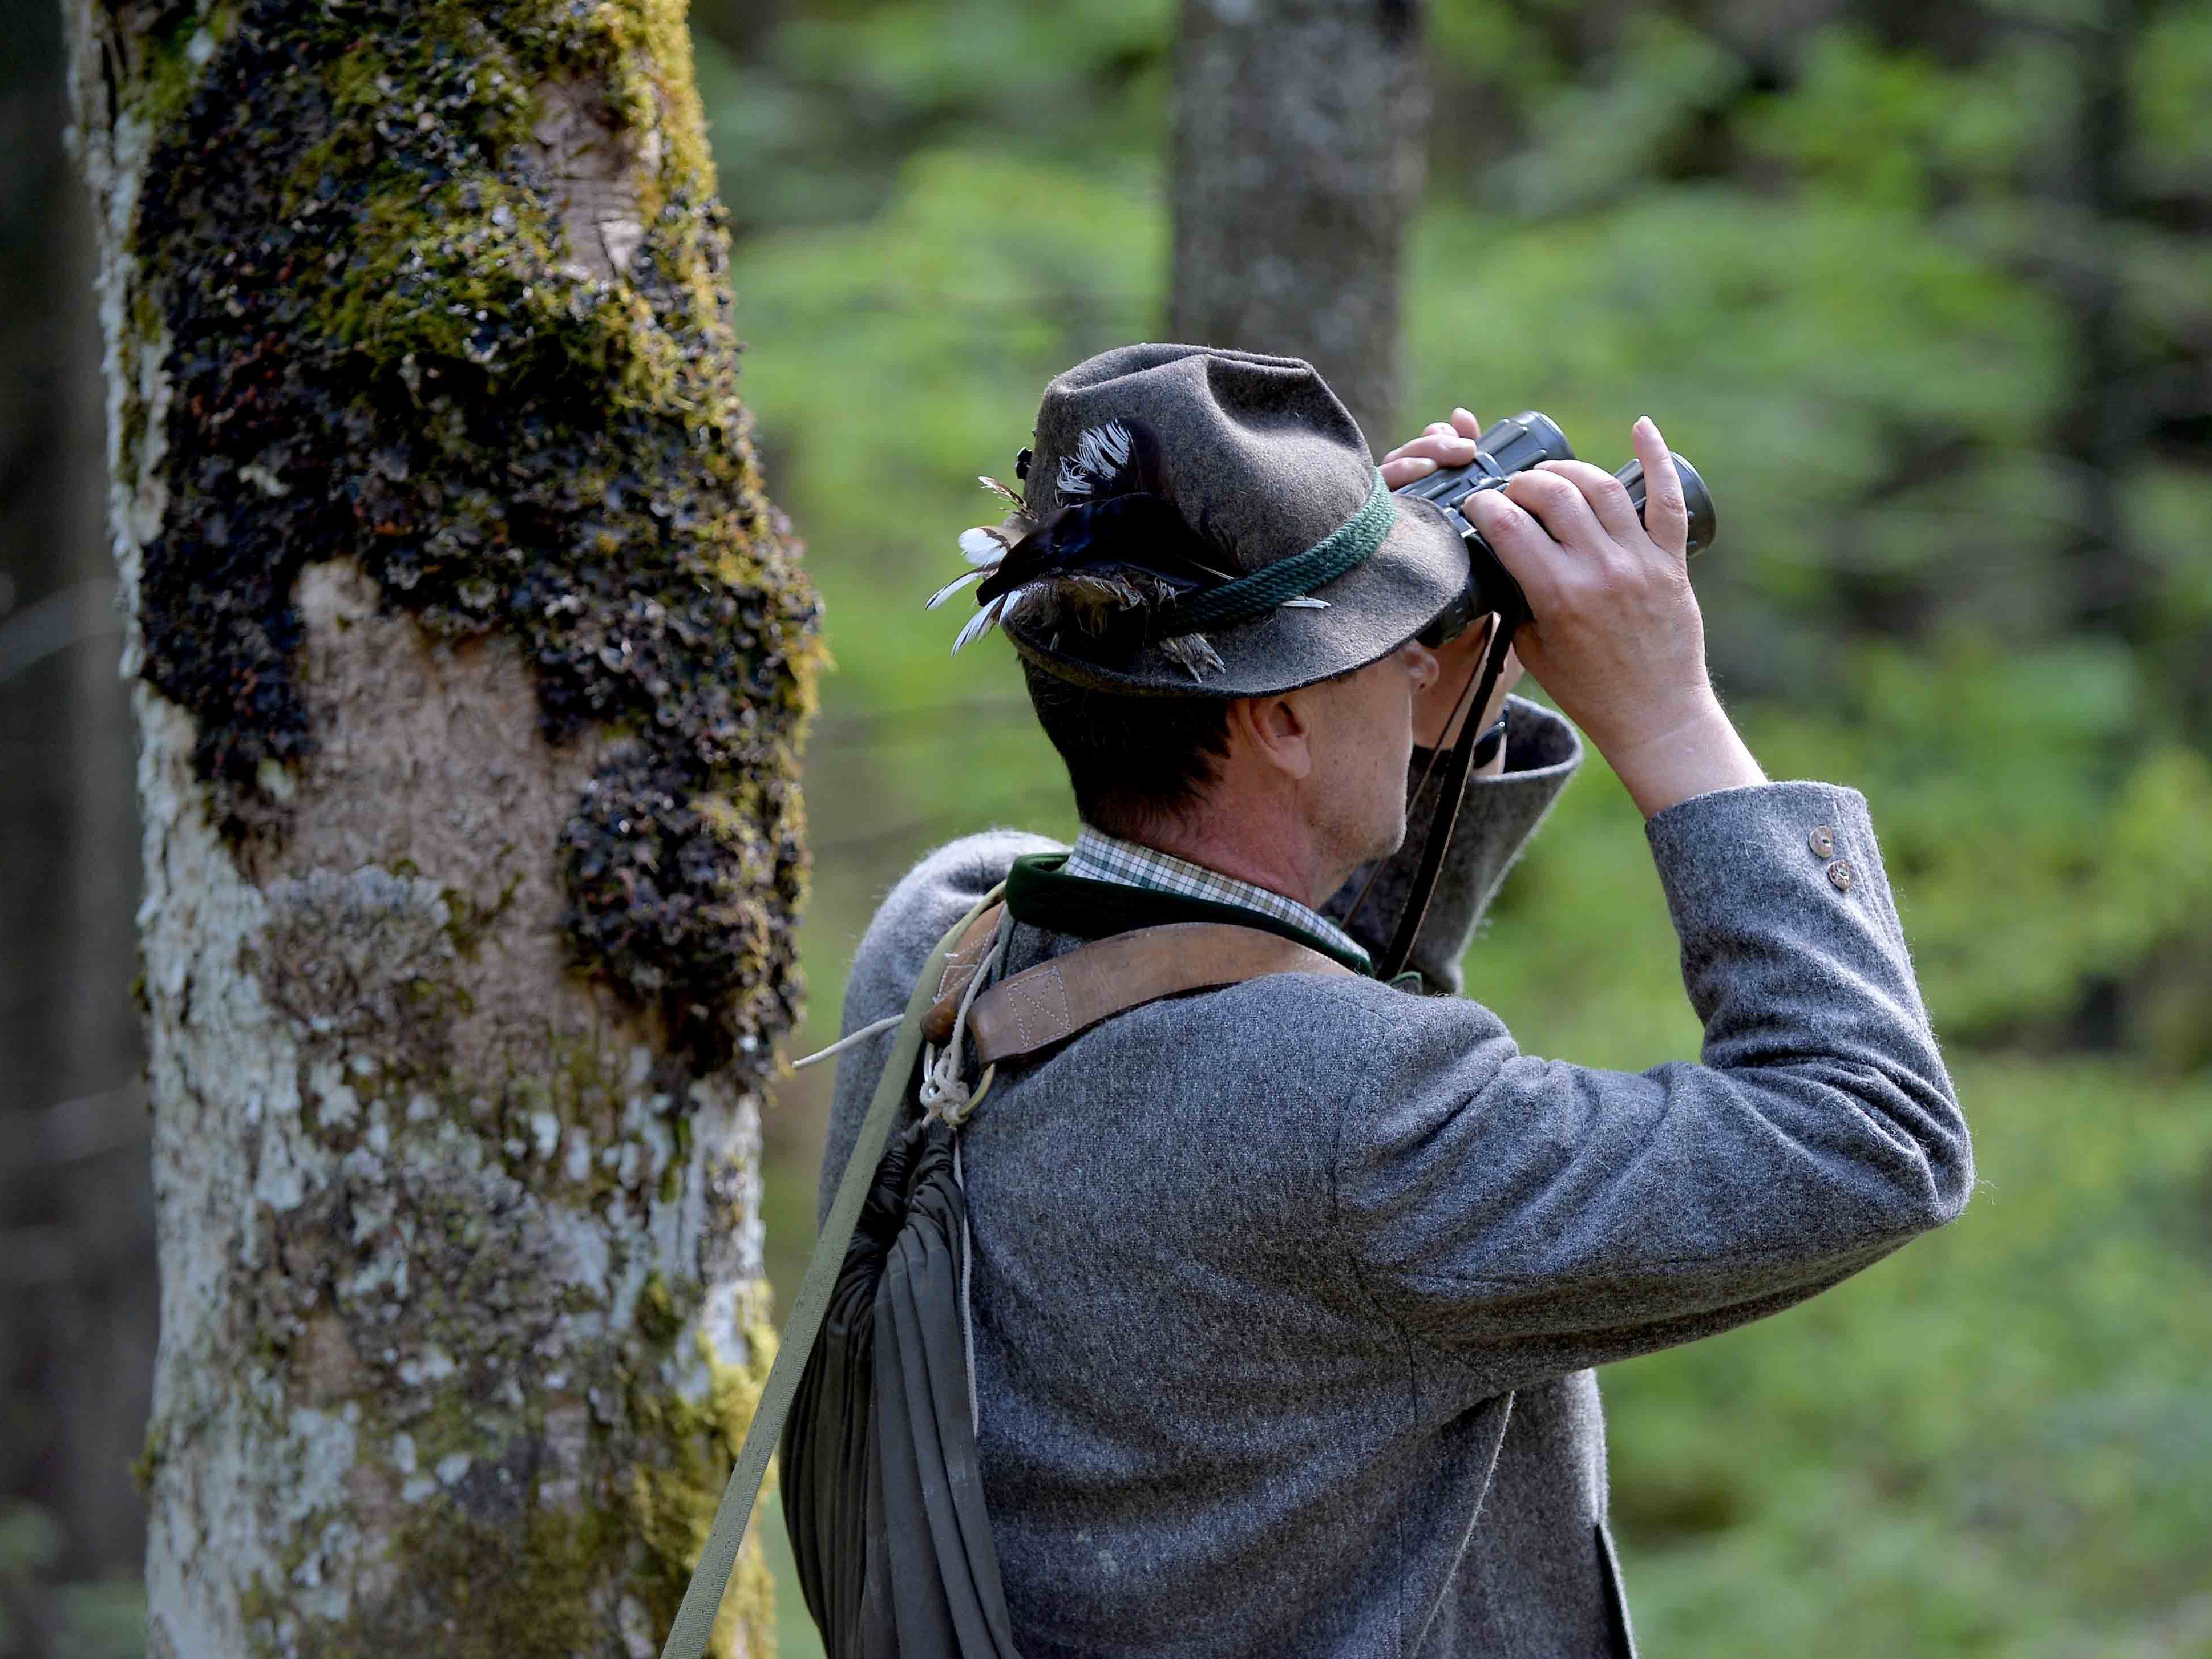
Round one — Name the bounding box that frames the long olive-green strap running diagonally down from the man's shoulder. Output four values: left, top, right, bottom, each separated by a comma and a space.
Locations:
661, 887, 1000, 1659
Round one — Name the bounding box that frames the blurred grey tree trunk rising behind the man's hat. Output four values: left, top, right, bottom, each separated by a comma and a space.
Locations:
1168, 0, 1429, 444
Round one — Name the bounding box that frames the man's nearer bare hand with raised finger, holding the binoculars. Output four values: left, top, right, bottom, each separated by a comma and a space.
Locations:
1469, 418, 1765, 819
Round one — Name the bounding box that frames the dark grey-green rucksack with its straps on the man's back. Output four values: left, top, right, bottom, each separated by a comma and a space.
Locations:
661, 889, 1349, 1659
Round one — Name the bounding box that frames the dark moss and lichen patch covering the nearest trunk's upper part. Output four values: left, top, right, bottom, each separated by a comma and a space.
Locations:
123, 0, 820, 1071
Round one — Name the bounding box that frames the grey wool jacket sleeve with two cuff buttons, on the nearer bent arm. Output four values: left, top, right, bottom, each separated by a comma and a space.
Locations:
1336, 783, 1973, 1391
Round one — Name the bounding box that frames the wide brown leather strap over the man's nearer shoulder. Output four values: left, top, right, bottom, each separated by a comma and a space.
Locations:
969, 922, 1352, 1066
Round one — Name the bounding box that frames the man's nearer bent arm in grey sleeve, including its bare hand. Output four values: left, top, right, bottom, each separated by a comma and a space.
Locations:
1336, 420, 1973, 1389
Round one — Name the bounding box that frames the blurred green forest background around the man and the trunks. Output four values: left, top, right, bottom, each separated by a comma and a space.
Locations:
0, 0, 2212, 1657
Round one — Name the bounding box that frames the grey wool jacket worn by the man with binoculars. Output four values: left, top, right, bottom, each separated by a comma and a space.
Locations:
823, 701, 1973, 1659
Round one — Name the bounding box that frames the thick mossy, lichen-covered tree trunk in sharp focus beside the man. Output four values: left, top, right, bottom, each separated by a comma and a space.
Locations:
66, 0, 818, 1659
